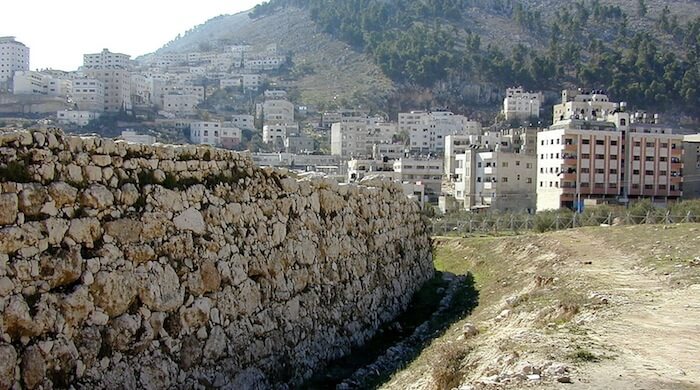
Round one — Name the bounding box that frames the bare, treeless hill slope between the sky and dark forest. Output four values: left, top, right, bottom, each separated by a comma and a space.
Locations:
156, 8, 394, 111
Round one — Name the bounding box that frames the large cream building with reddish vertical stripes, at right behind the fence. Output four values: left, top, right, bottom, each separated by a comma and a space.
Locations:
537, 113, 683, 211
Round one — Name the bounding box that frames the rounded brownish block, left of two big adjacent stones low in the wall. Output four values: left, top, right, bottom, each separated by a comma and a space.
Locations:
90, 271, 137, 317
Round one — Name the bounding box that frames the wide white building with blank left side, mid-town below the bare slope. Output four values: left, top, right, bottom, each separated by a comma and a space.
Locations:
331, 117, 398, 157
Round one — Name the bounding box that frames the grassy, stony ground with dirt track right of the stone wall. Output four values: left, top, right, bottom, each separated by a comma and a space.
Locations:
383, 224, 700, 390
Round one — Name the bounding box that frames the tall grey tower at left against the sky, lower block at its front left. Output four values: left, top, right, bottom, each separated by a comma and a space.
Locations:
83, 49, 131, 112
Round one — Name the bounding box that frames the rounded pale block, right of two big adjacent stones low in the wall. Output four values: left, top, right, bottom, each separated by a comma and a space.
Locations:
138, 264, 185, 312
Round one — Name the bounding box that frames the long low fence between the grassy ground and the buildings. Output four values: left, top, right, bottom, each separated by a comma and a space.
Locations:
433, 211, 700, 236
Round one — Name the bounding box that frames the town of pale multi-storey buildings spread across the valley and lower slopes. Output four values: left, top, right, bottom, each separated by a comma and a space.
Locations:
0, 37, 700, 213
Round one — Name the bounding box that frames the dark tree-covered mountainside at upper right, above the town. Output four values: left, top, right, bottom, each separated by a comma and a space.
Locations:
249, 0, 700, 117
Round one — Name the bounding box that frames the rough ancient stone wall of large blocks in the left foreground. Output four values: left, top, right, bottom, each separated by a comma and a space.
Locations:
0, 131, 433, 389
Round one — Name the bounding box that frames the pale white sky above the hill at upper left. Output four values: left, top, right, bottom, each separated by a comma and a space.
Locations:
0, 0, 262, 70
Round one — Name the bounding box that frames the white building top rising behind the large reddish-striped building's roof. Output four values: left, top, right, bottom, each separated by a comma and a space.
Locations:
553, 89, 625, 124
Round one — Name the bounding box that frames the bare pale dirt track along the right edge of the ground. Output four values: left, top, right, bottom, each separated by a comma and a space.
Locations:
548, 231, 700, 389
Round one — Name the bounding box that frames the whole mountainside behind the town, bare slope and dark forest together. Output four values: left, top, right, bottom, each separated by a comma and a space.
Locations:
154, 0, 700, 117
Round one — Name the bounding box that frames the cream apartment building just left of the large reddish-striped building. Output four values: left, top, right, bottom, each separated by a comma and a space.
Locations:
454, 146, 537, 212
